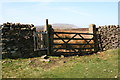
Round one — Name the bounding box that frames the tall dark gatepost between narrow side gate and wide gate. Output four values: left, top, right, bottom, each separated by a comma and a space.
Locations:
44, 19, 54, 55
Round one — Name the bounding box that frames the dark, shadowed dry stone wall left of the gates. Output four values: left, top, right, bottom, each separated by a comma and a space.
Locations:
1, 22, 35, 58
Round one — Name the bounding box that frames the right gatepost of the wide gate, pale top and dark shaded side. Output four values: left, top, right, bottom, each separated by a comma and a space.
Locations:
89, 24, 99, 52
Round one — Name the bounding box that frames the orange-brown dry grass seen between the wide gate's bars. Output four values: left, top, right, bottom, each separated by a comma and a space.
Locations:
54, 30, 94, 52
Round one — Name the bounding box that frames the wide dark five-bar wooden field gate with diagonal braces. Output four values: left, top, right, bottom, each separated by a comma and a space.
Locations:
53, 32, 97, 55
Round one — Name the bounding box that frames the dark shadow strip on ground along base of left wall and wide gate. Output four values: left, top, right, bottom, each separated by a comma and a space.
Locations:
2, 50, 96, 59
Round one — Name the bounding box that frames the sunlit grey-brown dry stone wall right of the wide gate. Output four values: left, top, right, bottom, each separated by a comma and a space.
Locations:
97, 25, 120, 50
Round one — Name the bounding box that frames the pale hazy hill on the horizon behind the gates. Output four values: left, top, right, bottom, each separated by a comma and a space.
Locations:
35, 24, 78, 30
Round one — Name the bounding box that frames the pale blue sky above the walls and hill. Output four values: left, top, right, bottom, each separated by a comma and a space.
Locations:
0, 1, 118, 27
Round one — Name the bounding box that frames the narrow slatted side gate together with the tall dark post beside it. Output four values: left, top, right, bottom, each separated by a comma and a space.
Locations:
34, 19, 54, 55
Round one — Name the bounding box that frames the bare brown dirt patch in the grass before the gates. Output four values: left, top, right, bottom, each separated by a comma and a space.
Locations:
29, 57, 74, 70
